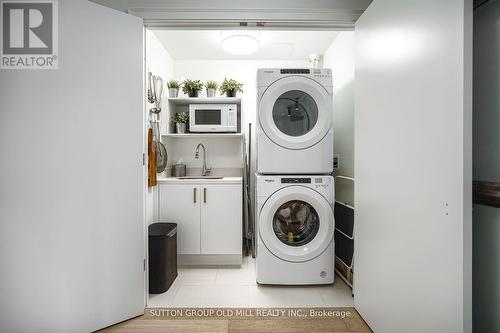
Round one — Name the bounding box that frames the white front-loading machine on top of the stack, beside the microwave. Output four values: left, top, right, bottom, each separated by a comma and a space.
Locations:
256, 68, 333, 174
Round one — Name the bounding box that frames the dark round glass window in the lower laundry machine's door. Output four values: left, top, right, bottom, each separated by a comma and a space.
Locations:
273, 200, 320, 246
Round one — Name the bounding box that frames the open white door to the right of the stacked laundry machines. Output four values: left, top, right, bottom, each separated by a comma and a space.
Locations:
354, 0, 472, 333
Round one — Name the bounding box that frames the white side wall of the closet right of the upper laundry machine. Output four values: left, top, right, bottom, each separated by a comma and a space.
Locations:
324, 31, 354, 205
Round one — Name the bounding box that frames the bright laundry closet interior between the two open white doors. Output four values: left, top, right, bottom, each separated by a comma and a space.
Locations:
145, 28, 354, 308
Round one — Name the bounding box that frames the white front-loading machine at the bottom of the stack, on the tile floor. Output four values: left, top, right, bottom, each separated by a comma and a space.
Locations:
256, 175, 335, 285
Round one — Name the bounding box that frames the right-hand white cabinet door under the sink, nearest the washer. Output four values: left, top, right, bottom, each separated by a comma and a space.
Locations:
200, 184, 243, 254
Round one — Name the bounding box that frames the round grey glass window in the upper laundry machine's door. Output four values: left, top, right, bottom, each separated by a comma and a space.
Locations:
273, 90, 318, 136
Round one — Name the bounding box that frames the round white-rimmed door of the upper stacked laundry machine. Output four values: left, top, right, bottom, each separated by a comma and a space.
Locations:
259, 76, 332, 150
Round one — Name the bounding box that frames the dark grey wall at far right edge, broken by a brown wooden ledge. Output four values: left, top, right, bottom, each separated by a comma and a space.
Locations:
473, 1, 500, 332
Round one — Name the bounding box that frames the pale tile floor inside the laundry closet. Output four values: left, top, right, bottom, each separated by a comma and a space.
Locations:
148, 257, 354, 308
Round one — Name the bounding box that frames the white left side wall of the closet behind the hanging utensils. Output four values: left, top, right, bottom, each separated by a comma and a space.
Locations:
146, 30, 174, 225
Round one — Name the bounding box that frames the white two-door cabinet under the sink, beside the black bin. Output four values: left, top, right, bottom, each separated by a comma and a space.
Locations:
158, 182, 243, 264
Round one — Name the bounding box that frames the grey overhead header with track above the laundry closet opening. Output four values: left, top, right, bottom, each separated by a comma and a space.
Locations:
89, 0, 372, 30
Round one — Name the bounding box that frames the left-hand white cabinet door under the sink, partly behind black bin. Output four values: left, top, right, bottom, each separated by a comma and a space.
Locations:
159, 184, 201, 254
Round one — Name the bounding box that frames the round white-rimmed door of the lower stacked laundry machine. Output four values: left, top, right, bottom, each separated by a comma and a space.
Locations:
259, 186, 334, 262
